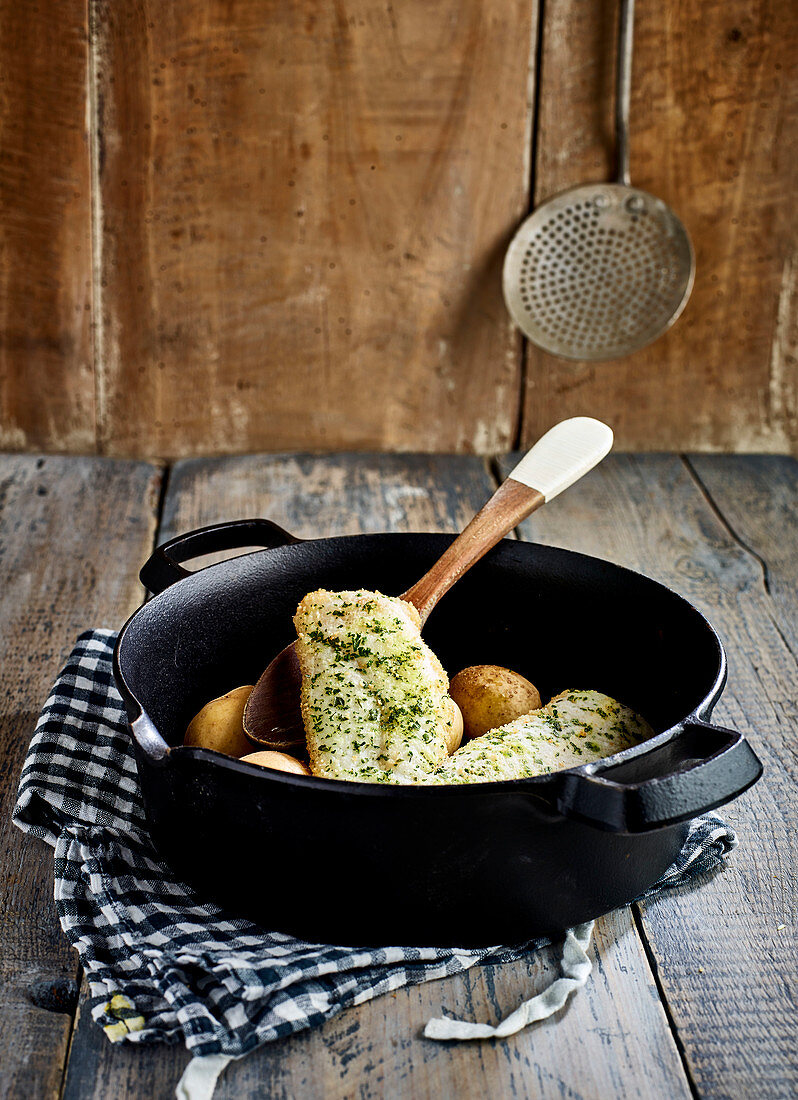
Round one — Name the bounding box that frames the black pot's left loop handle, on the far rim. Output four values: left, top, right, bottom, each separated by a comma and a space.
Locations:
139, 519, 303, 595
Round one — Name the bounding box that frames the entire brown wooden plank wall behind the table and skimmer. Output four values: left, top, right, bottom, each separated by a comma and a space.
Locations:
0, 0, 798, 458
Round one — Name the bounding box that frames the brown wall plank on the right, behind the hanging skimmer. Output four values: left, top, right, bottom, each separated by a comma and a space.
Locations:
522, 0, 798, 452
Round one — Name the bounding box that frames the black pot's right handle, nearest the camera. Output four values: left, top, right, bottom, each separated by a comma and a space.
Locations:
557, 719, 762, 833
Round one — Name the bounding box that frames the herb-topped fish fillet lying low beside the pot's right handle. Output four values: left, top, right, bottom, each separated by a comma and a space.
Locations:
434, 691, 654, 783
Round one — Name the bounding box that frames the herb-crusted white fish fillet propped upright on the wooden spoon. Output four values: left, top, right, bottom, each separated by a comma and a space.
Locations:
294, 590, 452, 783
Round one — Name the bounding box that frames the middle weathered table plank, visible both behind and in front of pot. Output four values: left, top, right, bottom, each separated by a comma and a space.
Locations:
59, 455, 689, 1100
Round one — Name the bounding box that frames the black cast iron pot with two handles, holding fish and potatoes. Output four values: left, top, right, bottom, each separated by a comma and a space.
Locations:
114, 519, 762, 945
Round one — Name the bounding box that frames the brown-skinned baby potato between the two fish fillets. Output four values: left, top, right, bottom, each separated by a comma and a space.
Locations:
449, 664, 540, 741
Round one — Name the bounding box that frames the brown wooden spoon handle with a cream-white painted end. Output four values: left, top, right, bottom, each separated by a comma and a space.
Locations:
402, 416, 612, 625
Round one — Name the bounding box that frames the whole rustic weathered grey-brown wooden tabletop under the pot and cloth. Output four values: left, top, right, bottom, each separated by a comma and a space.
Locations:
0, 454, 798, 1100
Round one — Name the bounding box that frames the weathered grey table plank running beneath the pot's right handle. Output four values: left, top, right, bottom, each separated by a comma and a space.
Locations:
497, 455, 798, 1100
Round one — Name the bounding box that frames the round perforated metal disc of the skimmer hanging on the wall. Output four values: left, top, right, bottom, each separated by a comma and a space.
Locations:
503, 184, 695, 360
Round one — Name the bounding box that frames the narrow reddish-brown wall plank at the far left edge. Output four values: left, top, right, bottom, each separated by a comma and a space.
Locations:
0, 0, 95, 451
